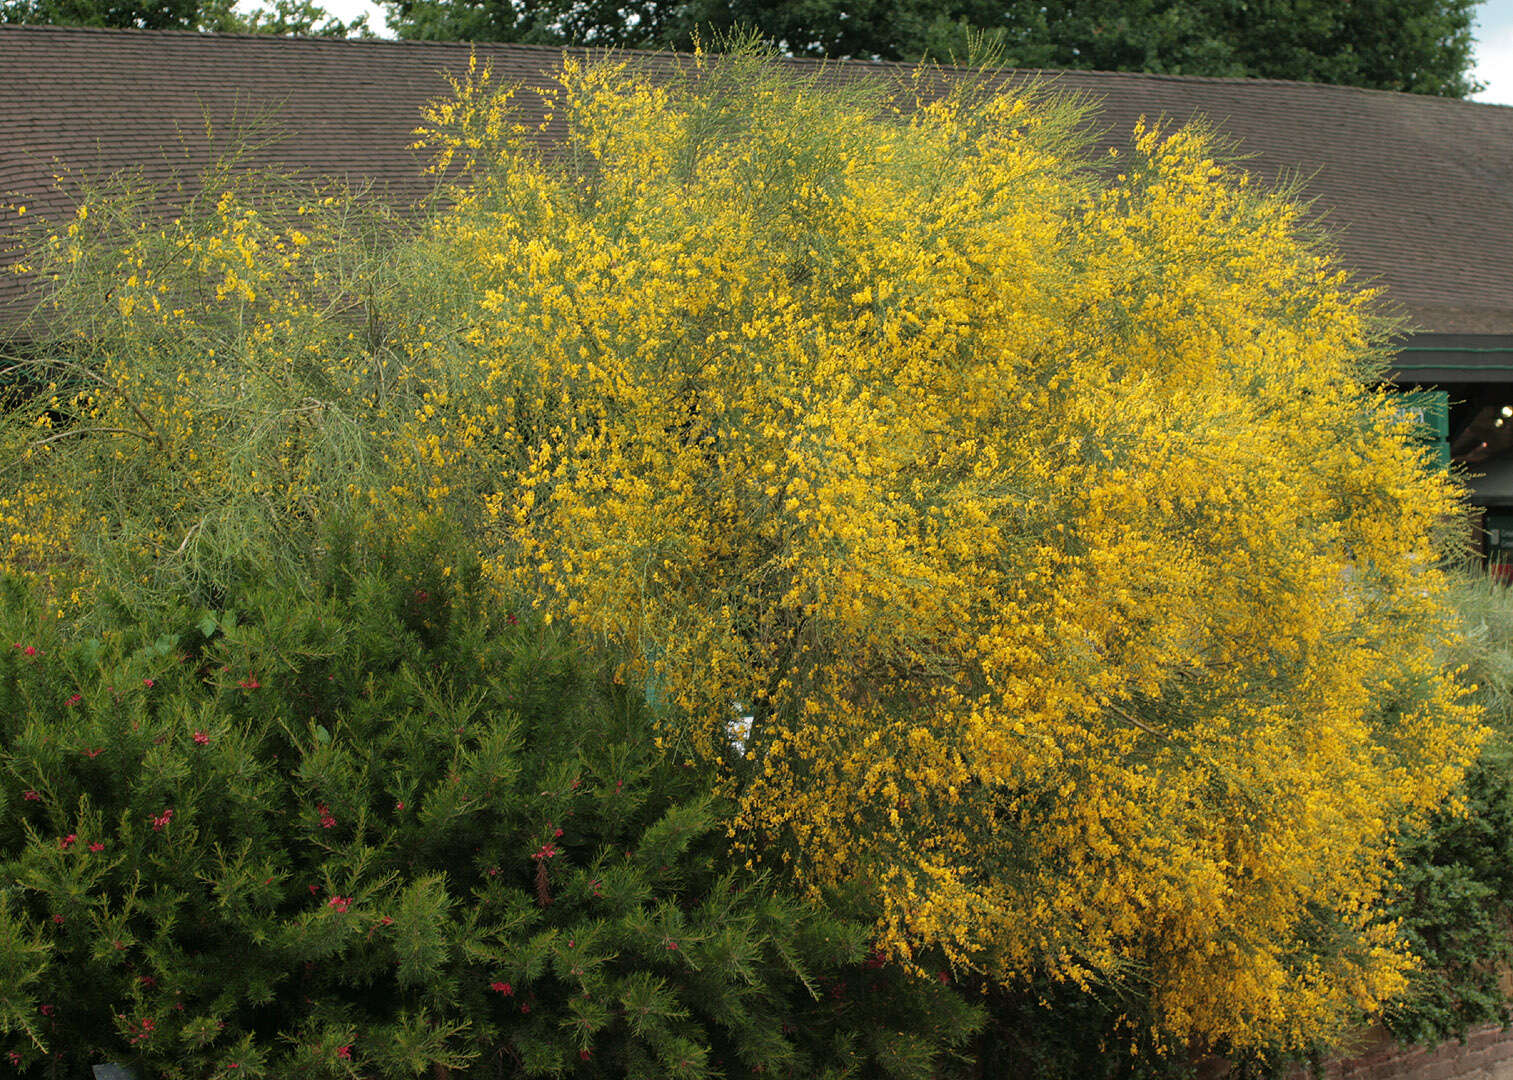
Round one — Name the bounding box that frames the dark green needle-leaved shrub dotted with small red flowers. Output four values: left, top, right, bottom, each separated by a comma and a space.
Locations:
0, 517, 977, 1077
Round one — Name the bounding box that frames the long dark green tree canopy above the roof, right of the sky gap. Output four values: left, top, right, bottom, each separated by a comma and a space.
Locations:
384, 0, 1480, 97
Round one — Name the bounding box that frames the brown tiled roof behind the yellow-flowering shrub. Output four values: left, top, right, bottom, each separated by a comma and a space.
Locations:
0, 26, 1513, 334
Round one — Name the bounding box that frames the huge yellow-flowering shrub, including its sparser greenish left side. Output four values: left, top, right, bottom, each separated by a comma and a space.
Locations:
0, 48, 1481, 1047
